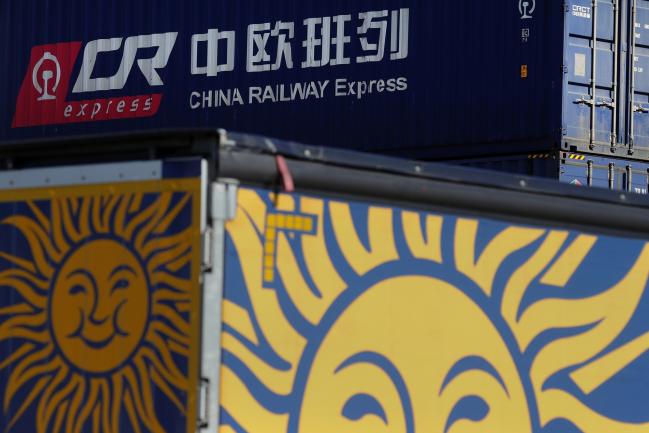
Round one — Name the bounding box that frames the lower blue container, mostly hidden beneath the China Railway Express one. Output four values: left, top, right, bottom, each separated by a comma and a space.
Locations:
447, 152, 649, 194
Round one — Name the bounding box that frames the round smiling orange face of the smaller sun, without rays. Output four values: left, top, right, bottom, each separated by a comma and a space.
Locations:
50, 239, 149, 373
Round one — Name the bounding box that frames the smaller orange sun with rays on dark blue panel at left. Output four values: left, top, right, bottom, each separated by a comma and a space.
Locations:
0, 180, 200, 433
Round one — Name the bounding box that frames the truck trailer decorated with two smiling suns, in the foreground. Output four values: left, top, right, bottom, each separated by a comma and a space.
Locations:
0, 131, 649, 433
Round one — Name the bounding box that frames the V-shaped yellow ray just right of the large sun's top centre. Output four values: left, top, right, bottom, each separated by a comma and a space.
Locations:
455, 218, 545, 296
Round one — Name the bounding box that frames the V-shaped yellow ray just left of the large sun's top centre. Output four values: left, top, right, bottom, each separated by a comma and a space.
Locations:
329, 202, 399, 275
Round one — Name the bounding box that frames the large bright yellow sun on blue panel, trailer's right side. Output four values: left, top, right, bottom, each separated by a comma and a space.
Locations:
220, 189, 649, 433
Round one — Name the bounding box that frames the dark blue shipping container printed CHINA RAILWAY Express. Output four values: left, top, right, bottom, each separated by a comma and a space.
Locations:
0, 0, 649, 159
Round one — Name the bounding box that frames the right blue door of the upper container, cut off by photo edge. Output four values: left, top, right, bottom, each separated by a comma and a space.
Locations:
628, 0, 649, 153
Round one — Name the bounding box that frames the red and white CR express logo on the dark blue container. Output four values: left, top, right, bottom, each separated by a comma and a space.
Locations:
12, 32, 178, 128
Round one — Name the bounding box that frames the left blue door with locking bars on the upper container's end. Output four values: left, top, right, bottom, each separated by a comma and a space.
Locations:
564, 0, 619, 148
